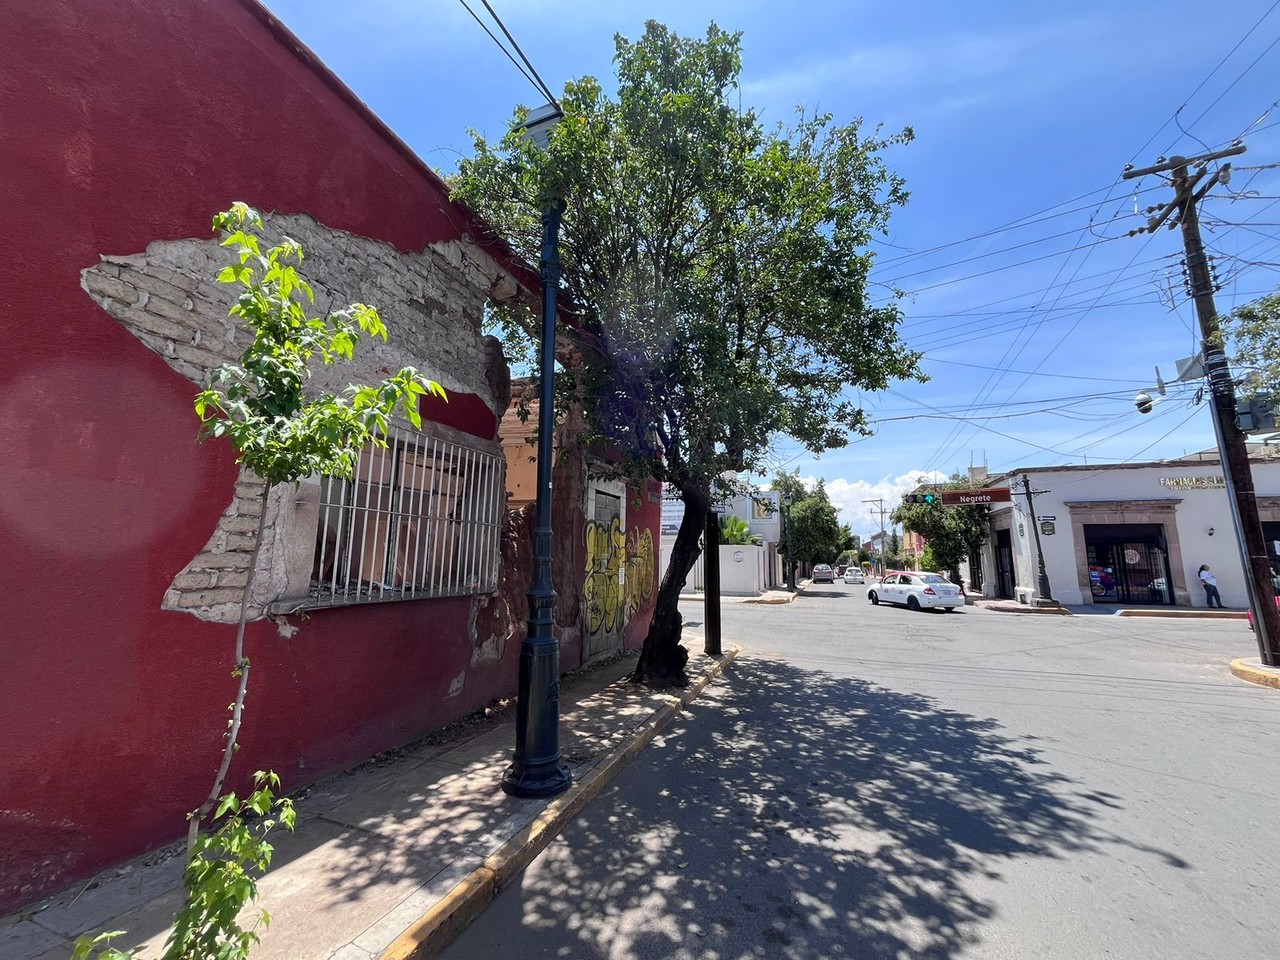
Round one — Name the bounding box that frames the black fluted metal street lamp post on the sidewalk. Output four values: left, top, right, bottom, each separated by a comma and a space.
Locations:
502, 108, 572, 797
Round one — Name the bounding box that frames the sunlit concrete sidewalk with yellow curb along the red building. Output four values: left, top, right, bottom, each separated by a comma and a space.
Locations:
0, 644, 739, 960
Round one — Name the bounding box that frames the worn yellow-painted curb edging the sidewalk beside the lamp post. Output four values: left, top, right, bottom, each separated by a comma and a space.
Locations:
379, 644, 742, 960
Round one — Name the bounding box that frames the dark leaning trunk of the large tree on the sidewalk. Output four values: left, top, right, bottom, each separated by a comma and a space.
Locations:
631, 489, 710, 686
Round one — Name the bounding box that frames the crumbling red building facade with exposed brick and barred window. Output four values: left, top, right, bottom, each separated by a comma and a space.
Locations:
0, 0, 660, 911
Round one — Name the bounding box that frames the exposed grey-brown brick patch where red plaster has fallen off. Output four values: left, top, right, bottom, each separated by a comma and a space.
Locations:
81, 214, 517, 622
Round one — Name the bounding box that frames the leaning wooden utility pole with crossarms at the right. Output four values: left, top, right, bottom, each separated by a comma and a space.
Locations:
1124, 143, 1280, 667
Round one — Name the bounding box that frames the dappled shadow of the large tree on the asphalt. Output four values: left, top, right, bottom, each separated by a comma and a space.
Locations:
447, 658, 1189, 960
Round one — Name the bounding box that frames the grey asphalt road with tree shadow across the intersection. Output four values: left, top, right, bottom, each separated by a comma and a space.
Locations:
445, 584, 1280, 960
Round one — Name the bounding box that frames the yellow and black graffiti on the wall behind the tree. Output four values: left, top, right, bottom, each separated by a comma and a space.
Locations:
582, 517, 657, 635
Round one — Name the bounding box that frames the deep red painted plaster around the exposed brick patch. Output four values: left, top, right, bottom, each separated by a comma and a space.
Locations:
0, 0, 535, 910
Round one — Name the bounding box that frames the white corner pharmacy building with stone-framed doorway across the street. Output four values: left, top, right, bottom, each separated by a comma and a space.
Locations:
965, 448, 1280, 607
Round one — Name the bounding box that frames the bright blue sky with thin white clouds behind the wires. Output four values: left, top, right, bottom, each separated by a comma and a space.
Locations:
269, 0, 1280, 535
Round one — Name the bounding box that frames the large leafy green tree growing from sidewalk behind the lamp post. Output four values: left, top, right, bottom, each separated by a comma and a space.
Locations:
454, 20, 920, 685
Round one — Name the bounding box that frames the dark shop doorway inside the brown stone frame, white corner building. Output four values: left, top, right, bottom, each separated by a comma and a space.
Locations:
1084, 524, 1174, 604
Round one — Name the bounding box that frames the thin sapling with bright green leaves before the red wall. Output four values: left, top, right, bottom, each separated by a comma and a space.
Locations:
73, 202, 448, 960
